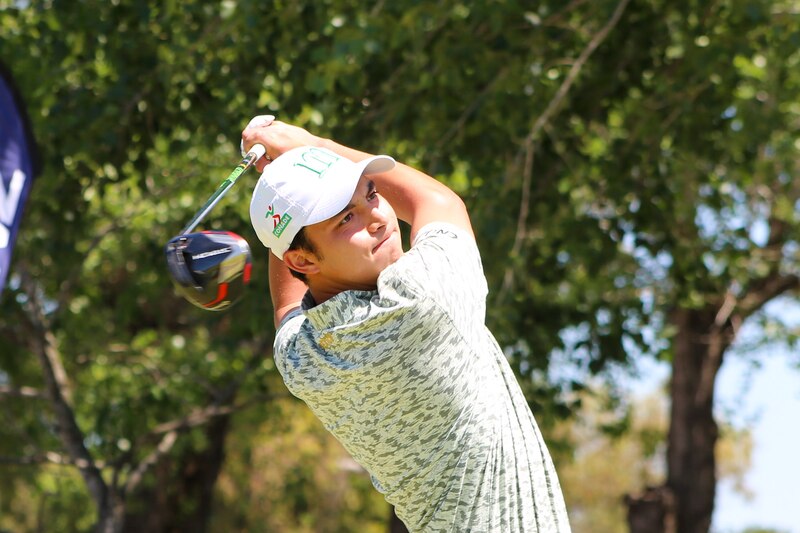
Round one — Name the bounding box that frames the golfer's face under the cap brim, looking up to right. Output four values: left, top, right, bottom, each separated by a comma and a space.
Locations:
306, 176, 403, 289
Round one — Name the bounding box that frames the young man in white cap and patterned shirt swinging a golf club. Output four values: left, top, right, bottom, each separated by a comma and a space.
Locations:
242, 117, 570, 533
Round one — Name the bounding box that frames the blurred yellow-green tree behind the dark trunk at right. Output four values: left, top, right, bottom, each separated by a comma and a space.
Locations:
556, 383, 752, 533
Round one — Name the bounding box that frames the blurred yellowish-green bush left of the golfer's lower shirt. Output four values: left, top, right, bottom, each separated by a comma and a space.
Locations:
210, 390, 390, 533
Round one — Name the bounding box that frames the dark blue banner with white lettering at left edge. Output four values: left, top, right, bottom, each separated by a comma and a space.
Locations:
0, 64, 34, 293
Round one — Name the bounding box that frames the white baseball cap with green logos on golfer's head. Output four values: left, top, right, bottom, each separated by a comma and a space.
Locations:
250, 146, 395, 260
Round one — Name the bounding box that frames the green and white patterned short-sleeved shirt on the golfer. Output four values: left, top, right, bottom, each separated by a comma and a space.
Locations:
274, 223, 570, 533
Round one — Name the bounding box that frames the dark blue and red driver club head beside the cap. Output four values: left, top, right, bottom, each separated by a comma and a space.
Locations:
165, 231, 252, 311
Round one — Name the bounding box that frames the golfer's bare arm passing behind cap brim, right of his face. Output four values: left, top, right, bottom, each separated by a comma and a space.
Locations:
320, 139, 472, 237
